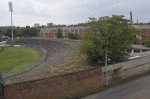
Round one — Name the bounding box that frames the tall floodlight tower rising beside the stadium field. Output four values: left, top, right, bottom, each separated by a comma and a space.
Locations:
8, 2, 14, 46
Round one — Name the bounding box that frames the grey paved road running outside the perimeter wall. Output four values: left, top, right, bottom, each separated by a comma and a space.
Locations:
81, 76, 150, 99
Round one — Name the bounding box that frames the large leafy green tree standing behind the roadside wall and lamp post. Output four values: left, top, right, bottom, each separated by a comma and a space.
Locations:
81, 15, 137, 62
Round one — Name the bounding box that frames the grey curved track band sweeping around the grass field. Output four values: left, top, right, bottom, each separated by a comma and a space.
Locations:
5, 39, 73, 84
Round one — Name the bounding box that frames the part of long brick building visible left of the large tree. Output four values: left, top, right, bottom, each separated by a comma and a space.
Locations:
40, 25, 87, 39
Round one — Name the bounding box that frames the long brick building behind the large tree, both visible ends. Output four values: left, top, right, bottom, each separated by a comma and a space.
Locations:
40, 24, 150, 45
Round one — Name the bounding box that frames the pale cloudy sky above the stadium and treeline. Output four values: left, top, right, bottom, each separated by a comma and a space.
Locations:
0, 0, 150, 26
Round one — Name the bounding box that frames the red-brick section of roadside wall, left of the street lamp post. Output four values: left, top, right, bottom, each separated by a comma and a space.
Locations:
4, 68, 103, 99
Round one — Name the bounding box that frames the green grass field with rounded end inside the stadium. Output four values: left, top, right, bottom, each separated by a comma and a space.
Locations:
0, 47, 40, 73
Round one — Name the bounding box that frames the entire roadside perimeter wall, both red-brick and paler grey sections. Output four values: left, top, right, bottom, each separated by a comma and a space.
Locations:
4, 52, 150, 99
